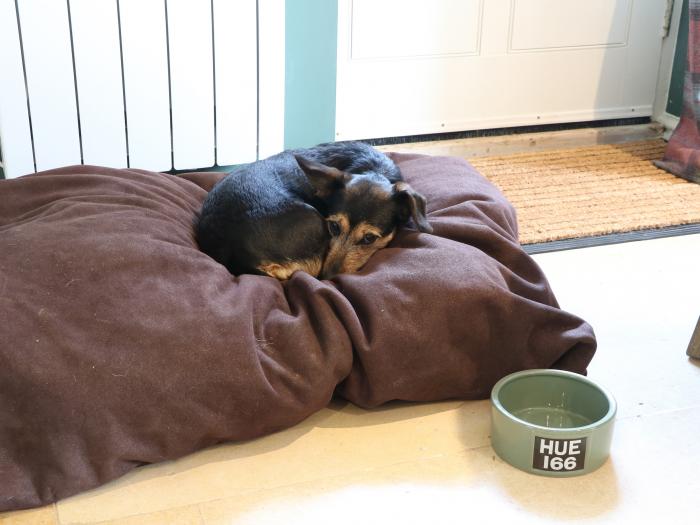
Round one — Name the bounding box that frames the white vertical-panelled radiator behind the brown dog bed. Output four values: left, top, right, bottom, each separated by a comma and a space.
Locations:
0, 0, 285, 178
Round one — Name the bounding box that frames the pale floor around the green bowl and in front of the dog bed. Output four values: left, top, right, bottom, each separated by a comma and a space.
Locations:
0, 235, 700, 525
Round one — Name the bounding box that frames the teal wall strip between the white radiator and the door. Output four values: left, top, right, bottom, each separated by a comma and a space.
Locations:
284, 0, 338, 148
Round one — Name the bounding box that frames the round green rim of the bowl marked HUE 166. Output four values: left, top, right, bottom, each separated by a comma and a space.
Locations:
491, 368, 617, 434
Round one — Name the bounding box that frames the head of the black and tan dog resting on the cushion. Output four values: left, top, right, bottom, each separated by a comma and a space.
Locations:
295, 155, 433, 279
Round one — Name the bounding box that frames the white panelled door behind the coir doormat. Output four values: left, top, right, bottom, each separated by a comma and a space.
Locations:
336, 0, 666, 140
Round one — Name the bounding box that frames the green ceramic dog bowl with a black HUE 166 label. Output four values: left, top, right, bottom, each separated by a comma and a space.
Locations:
491, 370, 617, 477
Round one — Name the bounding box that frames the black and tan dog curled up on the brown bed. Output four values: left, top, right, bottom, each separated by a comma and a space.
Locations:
195, 142, 432, 280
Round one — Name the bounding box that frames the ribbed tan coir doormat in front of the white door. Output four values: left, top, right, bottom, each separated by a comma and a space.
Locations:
469, 139, 700, 244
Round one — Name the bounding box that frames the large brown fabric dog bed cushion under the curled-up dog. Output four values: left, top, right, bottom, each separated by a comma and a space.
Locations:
0, 151, 595, 510
